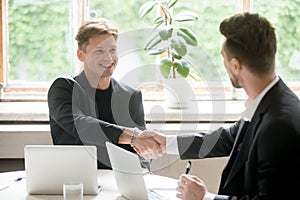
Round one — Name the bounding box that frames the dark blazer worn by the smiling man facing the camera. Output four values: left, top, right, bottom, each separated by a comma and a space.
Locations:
48, 72, 145, 168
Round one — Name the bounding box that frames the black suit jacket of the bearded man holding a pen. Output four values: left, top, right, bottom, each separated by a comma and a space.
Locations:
178, 79, 300, 199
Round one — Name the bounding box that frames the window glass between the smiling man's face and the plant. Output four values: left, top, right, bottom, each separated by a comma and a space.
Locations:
88, 0, 157, 85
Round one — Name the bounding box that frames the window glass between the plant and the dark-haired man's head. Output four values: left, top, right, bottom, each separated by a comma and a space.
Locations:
179, 0, 239, 81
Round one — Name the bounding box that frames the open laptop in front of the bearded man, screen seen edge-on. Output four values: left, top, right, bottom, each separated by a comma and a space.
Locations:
106, 142, 178, 200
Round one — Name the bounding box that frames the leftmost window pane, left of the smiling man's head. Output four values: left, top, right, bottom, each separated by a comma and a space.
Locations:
7, 0, 77, 83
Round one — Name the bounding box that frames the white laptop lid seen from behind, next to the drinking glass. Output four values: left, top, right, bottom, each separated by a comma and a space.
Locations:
24, 145, 100, 195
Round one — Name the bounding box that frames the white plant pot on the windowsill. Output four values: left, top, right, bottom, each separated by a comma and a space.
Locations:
163, 78, 193, 109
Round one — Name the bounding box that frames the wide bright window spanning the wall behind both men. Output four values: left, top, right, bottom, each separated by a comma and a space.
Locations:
0, 0, 300, 100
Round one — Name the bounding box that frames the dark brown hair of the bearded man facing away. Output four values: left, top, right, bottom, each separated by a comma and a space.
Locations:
219, 13, 277, 75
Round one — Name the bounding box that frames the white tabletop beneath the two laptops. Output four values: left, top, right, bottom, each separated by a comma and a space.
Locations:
0, 170, 177, 200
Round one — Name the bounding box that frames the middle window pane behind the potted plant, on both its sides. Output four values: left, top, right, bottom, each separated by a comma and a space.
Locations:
89, 0, 237, 85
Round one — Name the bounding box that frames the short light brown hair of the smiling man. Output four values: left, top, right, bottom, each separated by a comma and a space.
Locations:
75, 18, 118, 52
